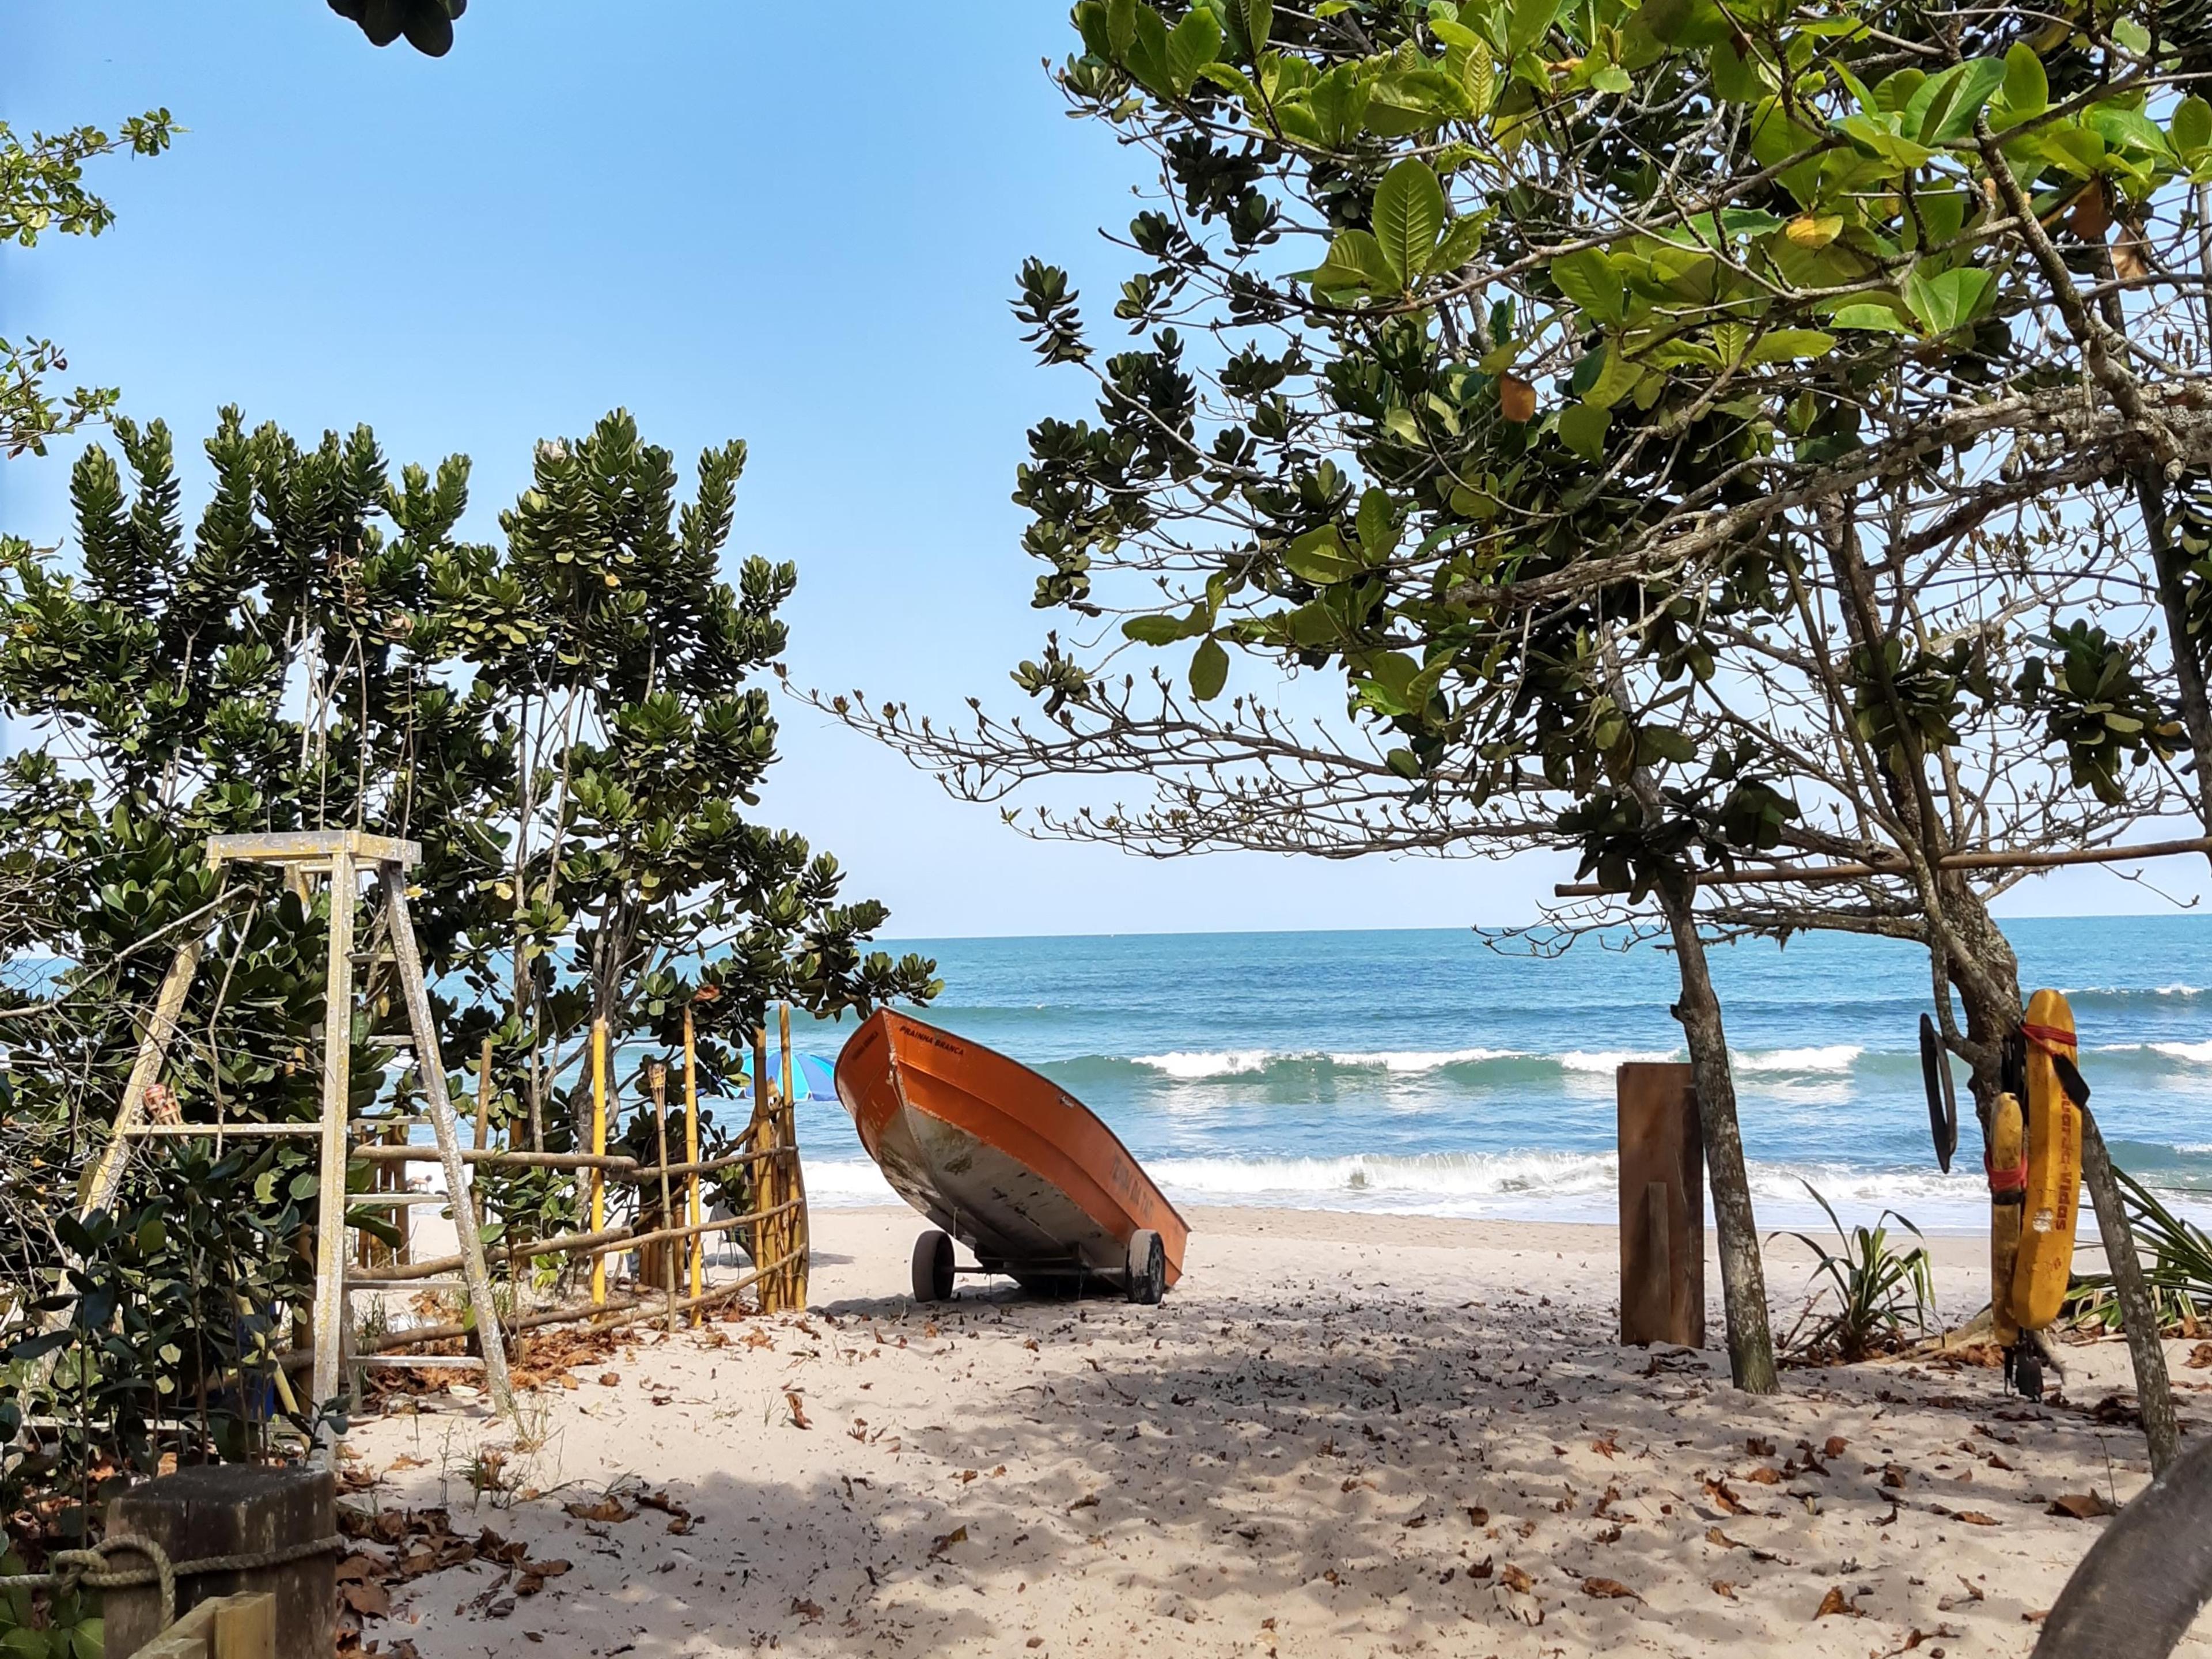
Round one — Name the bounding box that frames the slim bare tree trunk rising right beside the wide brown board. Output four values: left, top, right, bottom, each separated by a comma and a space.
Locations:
1659, 880, 1781, 1393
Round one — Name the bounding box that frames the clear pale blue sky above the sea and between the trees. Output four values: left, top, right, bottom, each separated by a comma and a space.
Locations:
0, 0, 2196, 935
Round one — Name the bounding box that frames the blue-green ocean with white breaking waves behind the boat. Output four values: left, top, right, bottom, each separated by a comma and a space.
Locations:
794, 916, 2212, 1232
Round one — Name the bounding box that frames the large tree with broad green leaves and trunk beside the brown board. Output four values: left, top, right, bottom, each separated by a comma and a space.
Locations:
832, 0, 2212, 1407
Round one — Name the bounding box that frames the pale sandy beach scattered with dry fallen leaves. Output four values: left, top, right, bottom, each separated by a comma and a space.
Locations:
345, 1210, 2212, 1659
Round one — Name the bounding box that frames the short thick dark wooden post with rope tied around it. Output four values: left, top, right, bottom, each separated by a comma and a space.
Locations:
104, 1462, 339, 1659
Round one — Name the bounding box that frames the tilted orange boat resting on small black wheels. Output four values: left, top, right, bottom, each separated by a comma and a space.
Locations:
836, 1009, 1190, 1303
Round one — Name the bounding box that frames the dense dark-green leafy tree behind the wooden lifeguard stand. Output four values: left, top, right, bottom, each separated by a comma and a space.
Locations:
0, 409, 935, 1504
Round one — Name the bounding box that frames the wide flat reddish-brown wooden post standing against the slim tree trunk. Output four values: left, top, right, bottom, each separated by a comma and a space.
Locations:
1615, 1062, 1706, 1347
